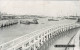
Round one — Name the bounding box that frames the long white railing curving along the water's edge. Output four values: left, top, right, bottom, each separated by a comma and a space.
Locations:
0, 23, 80, 50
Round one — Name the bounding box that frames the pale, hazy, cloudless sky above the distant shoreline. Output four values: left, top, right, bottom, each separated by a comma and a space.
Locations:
0, 0, 80, 16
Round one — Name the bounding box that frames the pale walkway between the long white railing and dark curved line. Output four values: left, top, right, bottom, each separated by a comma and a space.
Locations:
40, 28, 79, 50
